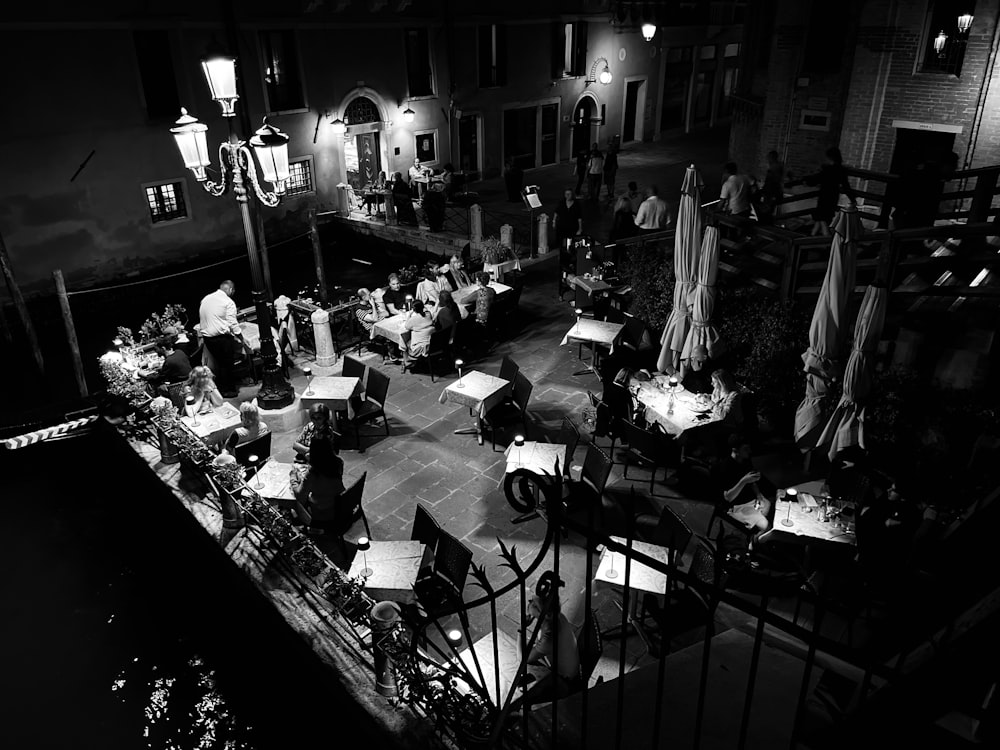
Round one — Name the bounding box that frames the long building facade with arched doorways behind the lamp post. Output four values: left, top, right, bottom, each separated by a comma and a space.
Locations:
0, 0, 743, 294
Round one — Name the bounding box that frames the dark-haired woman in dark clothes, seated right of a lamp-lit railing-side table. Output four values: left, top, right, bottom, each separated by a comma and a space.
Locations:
289, 436, 344, 534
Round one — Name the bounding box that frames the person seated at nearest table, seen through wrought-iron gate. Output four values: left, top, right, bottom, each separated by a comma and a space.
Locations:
513, 571, 583, 707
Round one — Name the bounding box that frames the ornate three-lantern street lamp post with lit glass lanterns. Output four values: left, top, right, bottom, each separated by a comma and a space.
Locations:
170, 55, 295, 409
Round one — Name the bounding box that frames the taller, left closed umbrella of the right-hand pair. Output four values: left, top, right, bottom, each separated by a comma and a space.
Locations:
795, 206, 863, 451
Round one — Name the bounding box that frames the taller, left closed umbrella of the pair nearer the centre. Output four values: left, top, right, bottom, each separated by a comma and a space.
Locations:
656, 164, 703, 372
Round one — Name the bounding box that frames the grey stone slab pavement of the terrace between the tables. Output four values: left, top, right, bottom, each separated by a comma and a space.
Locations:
260, 261, 812, 676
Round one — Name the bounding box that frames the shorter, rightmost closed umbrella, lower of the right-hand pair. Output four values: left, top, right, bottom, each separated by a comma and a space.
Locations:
819, 286, 889, 460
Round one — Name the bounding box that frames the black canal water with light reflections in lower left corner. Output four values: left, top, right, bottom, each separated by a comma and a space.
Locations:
0, 428, 393, 750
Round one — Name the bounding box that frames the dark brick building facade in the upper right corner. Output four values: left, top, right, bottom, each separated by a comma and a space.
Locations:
730, 0, 1000, 194
